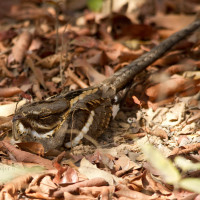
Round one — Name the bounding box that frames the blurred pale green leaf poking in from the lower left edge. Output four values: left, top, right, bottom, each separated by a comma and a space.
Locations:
0, 164, 44, 184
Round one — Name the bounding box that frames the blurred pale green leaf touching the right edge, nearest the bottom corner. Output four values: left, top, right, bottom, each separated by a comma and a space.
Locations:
180, 178, 200, 194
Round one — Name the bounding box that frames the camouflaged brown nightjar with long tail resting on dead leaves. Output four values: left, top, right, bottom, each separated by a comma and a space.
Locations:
13, 20, 200, 151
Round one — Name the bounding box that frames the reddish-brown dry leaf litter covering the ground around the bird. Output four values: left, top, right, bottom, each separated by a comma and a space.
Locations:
0, 0, 200, 199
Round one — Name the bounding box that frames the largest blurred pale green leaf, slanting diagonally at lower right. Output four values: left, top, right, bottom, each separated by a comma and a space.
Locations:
142, 144, 181, 186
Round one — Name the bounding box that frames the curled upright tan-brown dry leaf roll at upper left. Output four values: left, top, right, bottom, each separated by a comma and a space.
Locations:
12, 31, 32, 63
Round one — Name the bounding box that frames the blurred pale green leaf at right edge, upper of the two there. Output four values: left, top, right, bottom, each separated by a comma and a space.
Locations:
174, 156, 200, 172
